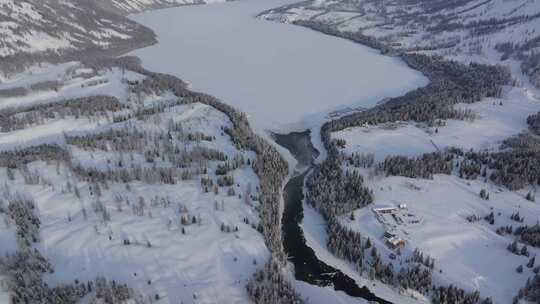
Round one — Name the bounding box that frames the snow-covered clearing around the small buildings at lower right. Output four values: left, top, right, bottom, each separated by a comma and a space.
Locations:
342, 175, 540, 303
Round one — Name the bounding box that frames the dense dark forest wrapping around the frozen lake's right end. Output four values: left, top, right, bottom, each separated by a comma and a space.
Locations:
326, 54, 510, 132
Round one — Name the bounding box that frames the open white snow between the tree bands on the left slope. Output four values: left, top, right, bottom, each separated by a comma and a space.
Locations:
0, 66, 269, 303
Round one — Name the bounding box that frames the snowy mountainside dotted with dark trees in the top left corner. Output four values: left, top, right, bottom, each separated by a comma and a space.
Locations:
0, 0, 155, 73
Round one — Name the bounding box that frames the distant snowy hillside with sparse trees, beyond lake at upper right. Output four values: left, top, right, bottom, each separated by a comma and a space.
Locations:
261, 0, 540, 85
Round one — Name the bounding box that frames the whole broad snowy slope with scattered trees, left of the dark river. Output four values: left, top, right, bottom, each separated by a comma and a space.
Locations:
0, 63, 276, 303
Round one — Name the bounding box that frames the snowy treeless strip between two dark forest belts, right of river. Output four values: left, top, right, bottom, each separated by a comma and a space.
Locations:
333, 87, 540, 161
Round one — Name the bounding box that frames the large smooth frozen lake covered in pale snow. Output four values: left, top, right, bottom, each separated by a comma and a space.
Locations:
132, 0, 427, 131
